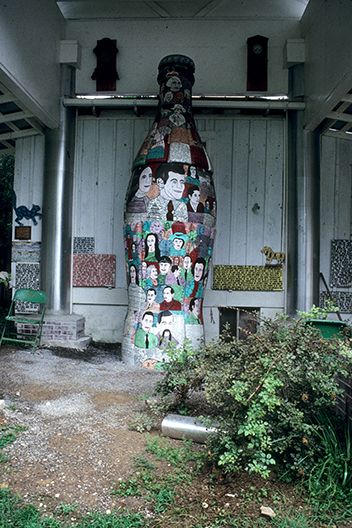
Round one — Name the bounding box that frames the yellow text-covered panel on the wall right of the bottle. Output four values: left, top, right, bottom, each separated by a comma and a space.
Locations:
213, 265, 283, 291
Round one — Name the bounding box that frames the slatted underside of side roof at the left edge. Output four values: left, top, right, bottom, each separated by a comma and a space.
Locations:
0, 83, 43, 155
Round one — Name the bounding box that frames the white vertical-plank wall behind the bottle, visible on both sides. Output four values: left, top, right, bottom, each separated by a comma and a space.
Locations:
73, 114, 285, 340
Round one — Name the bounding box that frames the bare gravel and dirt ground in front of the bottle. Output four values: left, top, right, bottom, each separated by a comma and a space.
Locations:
0, 347, 160, 513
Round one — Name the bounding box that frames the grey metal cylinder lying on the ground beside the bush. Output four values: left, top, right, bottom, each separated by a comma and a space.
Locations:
161, 414, 218, 444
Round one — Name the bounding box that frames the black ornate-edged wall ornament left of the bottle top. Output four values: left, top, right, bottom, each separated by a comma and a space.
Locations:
92, 38, 119, 92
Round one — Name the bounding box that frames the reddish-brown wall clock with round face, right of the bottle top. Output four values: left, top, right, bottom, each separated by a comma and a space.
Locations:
247, 35, 268, 92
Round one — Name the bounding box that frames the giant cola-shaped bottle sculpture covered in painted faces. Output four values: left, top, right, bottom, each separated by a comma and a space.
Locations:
122, 55, 216, 367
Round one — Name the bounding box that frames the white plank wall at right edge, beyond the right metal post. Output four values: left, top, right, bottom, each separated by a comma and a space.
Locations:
320, 136, 352, 291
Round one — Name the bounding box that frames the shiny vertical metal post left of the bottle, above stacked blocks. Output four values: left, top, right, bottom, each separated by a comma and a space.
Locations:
41, 67, 75, 314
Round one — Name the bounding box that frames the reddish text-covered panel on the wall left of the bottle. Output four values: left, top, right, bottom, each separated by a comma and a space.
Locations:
73, 254, 116, 288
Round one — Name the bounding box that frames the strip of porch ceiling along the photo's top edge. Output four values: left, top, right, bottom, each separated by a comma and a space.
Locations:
57, 0, 308, 19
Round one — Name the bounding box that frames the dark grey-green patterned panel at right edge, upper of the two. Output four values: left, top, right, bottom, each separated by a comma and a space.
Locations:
330, 239, 352, 288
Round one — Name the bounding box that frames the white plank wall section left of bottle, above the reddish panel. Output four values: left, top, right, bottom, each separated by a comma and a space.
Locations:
73, 118, 151, 288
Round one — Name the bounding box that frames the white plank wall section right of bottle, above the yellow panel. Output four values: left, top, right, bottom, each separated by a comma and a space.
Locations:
204, 118, 284, 265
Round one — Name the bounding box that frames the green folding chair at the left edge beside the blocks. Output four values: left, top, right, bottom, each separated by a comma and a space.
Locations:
0, 288, 46, 350
